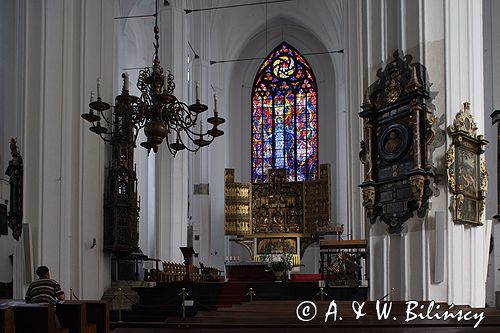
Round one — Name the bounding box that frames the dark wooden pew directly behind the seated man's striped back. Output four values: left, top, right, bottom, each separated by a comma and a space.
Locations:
12, 304, 69, 333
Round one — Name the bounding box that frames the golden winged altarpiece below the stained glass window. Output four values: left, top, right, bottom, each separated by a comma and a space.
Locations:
224, 164, 335, 265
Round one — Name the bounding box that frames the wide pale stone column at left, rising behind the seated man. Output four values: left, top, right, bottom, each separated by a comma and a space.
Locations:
8, 0, 113, 298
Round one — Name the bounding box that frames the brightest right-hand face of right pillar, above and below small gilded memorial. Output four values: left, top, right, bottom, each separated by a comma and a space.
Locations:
445, 0, 489, 307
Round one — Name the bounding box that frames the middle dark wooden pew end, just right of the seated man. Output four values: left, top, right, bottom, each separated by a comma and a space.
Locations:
56, 301, 96, 333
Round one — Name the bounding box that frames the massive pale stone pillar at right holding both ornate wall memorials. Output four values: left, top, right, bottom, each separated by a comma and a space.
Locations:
362, 0, 489, 307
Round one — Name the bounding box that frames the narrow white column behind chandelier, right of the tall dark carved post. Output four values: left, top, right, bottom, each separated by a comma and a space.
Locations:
156, 1, 190, 262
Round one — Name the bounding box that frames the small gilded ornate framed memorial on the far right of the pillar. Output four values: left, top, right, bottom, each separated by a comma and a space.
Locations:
447, 102, 488, 225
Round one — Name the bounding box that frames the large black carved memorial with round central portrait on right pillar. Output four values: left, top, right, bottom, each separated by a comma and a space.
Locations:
359, 51, 435, 233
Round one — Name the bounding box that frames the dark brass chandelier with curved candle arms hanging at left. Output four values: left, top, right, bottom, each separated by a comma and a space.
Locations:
82, 1, 225, 156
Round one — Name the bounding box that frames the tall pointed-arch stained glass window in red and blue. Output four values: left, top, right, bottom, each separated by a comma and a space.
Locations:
252, 42, 318, 182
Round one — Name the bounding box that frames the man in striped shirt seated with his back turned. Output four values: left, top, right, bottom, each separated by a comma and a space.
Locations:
25, 266, 64, 304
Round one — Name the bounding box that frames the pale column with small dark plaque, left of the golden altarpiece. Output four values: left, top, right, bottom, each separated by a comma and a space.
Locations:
187, 0, 228, 269
